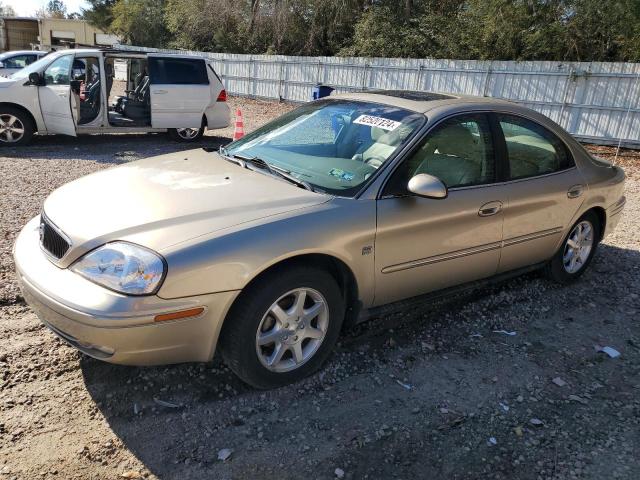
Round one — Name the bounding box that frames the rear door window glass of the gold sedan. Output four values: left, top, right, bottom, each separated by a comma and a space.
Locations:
498, 115, 573, 180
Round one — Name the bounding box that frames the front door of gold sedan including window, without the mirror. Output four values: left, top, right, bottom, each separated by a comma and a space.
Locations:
374, 114, 507, 305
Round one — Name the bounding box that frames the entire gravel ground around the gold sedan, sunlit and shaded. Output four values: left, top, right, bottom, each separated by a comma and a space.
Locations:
0, 99, 640, 479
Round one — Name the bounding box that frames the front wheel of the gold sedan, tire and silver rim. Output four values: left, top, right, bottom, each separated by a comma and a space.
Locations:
220, 266, 344, 389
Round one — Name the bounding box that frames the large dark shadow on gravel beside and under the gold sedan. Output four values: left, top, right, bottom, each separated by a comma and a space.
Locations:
81, 245, 640, 480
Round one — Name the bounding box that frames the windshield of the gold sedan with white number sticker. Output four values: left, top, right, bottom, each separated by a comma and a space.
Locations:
223, 100, 425, 196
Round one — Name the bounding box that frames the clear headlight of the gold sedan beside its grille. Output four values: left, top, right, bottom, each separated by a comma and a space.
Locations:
71, 242, 165, 295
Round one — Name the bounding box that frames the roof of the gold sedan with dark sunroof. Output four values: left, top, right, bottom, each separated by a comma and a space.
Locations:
331, 90, 515, 113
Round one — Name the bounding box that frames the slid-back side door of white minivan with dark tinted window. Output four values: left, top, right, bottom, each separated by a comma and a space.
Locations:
149, 55, 212, 128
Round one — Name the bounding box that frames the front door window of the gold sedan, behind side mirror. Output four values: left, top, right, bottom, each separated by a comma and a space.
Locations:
385, 114, 496, 196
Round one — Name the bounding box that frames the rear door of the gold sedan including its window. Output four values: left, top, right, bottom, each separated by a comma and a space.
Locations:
496, 114, 586, 272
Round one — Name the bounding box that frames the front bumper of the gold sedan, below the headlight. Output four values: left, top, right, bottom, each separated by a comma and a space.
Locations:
14, 217, 238, 365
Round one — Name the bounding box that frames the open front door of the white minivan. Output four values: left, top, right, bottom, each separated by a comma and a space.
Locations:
38, 55, 77, 137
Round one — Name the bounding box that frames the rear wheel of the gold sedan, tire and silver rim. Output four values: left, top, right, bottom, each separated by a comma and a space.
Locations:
545, 212, 602, 284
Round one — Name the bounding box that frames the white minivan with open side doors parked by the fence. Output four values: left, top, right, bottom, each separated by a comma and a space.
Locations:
0, 49, 230, 145
